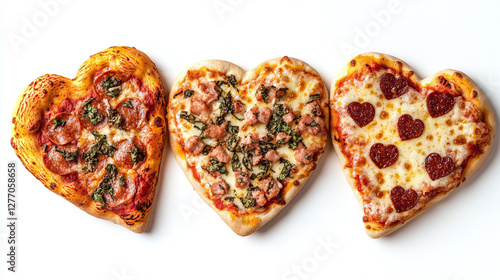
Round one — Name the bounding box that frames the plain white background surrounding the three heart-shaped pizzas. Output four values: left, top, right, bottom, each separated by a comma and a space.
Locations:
0, 0, 500, 280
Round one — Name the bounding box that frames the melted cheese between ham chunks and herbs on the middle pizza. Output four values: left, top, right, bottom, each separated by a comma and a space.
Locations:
170, 60, 327, 213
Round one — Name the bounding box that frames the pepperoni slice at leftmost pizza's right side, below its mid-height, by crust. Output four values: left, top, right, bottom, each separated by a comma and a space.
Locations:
113, 139, 147, 169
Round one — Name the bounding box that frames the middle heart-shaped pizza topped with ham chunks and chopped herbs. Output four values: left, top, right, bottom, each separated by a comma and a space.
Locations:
168, 57, 329, 236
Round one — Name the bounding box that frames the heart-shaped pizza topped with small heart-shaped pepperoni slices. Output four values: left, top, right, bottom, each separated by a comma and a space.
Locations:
330, 53, 495, 238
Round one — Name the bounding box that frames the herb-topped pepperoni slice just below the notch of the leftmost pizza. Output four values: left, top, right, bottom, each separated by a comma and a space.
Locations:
78, 97, 107, 130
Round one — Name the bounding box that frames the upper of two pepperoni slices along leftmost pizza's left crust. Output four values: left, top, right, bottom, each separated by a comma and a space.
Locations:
45, 113, 81, 145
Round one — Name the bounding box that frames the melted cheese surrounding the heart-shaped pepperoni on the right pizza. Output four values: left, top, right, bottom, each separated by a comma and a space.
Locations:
332, 70, 488, 223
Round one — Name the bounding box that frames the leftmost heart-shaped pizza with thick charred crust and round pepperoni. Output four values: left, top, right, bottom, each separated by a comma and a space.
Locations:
11, 47, 167, 233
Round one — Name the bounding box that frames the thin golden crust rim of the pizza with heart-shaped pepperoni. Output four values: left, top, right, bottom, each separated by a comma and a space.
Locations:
330, 53, 496, 238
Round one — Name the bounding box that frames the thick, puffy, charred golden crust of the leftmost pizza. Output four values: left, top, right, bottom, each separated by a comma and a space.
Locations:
11, 47, 166, 233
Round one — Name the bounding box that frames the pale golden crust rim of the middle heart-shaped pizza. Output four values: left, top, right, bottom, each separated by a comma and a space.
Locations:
167, 57, 329, 236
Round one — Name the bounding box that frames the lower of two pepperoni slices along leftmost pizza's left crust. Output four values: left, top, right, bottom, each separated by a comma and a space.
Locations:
43, 144, 80, 175
